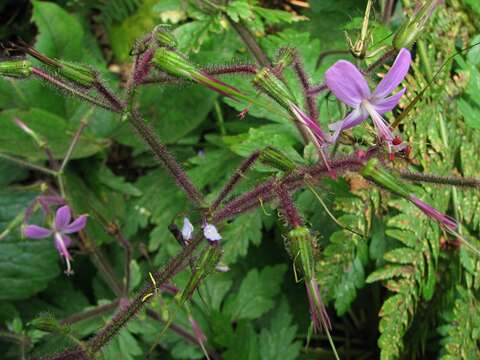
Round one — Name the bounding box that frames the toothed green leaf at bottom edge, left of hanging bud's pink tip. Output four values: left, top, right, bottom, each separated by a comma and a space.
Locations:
259, 299, 302, 360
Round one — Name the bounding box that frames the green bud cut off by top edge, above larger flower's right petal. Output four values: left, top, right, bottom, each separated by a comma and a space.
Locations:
393, 0, 443, 50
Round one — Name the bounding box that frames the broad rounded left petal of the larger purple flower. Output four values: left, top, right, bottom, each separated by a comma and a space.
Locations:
325, 60, 370, 107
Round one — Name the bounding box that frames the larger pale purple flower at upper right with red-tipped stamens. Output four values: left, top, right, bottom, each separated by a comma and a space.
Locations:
325, 49, 412, 152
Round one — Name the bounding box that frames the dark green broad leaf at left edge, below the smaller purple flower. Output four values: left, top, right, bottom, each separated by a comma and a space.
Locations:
0, 239, 60, 300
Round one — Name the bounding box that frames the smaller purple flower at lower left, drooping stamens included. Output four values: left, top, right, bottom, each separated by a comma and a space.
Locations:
23, 205, 87, 274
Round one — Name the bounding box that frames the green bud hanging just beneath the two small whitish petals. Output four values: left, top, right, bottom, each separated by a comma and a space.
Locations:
177, 244, 222, 304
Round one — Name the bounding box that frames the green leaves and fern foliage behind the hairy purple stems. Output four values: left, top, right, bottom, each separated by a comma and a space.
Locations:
0, 0, 480, 360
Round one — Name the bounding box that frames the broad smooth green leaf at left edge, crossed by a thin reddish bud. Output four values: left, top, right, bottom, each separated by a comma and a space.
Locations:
0, 109, 108, 160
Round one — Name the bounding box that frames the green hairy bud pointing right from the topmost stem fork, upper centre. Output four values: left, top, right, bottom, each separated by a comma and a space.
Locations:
153, 47, 250, 101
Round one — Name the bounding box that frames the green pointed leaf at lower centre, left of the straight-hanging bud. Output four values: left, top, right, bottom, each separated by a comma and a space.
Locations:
224, 265, 287, 320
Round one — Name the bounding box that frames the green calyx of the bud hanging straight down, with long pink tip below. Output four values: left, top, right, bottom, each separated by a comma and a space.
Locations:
288, 226, 315, 280
